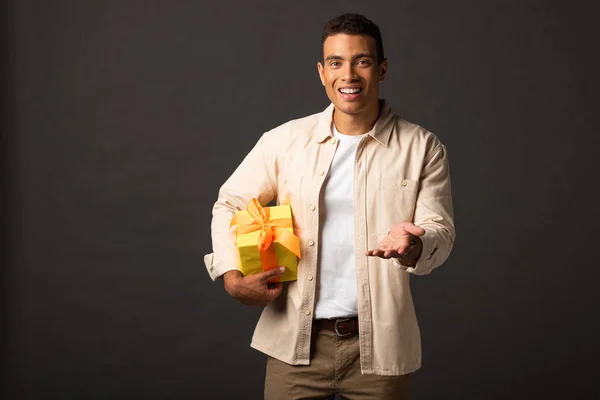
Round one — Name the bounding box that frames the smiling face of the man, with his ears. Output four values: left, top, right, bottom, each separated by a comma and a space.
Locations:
317, 34, 387, 116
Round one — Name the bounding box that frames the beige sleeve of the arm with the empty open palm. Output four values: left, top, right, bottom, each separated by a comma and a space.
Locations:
393, 143, 456, 275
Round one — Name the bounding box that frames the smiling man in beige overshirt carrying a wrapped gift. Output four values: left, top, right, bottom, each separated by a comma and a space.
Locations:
205, 14, 455, 399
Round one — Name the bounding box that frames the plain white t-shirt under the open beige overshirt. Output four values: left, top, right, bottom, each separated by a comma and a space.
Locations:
315, 126, 369, 319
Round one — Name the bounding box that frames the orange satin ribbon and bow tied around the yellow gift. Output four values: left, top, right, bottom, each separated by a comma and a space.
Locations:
229, 198, 301, 281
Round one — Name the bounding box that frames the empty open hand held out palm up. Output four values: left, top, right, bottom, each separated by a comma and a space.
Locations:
365, 221, 425, 264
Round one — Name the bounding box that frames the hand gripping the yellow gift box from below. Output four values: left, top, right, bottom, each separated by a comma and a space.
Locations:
223, 267, 285, 307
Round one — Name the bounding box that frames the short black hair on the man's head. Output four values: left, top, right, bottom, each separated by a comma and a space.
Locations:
321, 13, 385, 64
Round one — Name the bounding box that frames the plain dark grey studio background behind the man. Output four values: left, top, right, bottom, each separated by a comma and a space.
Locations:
2, 0, 600, 399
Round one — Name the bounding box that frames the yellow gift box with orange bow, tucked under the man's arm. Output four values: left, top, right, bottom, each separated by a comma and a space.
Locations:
230, 199, 301, 282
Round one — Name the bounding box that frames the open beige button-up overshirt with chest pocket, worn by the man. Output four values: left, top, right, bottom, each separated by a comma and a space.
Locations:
204, 101, 455, 375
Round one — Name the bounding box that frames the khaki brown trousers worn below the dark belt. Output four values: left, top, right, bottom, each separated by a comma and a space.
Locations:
265, 330, 411, 400
